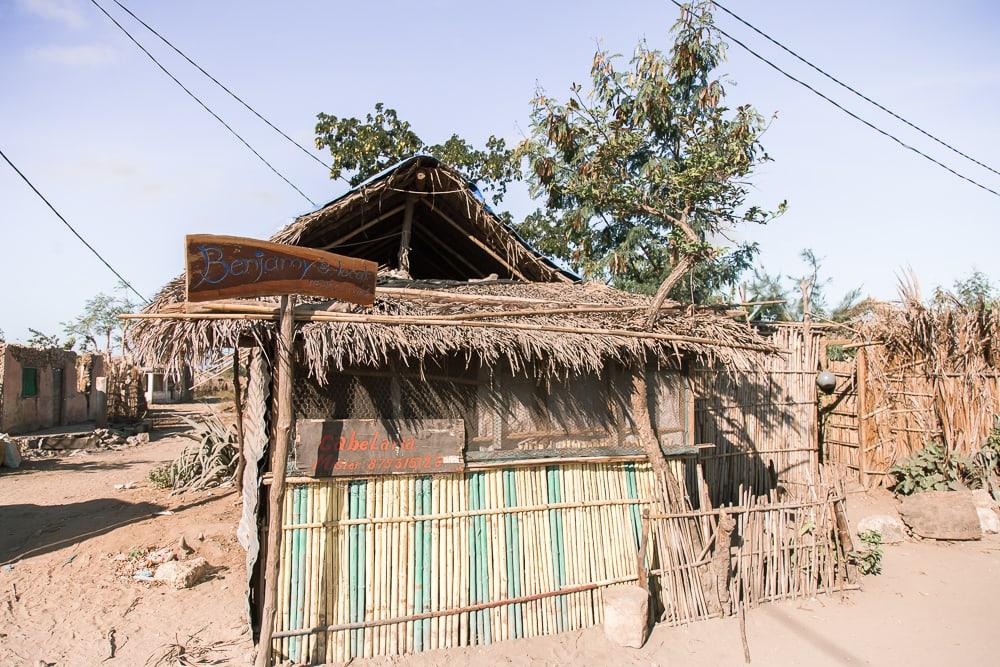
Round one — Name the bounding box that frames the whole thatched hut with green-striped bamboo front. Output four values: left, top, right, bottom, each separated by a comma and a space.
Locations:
130, 157, 856, 664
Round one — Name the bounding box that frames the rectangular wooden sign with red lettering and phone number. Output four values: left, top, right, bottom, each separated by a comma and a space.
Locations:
295, 419, 465, 477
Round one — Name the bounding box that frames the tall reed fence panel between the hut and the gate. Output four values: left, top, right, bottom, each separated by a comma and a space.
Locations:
691, 326, 820, 506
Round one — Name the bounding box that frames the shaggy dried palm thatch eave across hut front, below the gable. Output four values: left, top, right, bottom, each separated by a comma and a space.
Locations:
130, 281, 773, 380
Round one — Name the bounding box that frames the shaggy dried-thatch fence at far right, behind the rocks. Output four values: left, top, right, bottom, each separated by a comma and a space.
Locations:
857, 276, 1000, 481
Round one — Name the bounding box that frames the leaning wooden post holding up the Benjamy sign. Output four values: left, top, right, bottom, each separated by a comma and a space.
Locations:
255, 296, 295, 667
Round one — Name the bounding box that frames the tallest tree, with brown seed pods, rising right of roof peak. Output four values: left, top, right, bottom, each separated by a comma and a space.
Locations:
518, 1, 785, 316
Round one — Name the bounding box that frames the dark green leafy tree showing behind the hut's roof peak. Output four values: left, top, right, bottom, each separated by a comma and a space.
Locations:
316, 102, 520, 205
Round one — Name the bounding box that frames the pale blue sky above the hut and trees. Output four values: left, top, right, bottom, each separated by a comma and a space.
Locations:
0, 0, 1000, 340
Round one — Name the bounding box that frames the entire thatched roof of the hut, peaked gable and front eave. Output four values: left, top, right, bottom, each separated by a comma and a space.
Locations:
129, 157, 769, 380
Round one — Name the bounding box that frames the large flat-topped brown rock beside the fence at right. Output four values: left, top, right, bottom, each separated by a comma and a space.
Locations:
899, 491, 983, 540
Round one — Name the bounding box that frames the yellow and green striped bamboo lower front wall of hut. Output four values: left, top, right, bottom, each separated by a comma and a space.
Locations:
274, 463, 679, 664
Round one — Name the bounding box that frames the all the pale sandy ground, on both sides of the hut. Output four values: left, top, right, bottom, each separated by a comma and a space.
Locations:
0, 410, 1000, 667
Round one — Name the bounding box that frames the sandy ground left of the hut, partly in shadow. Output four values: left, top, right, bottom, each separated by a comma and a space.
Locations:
0, 408, 251, 667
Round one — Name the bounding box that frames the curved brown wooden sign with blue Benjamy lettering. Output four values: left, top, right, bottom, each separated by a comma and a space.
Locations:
185, 234, 378, 306
